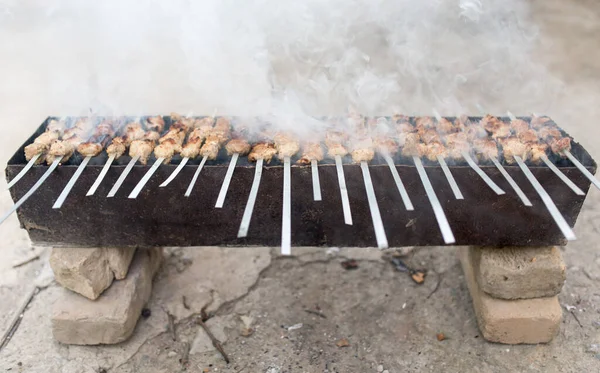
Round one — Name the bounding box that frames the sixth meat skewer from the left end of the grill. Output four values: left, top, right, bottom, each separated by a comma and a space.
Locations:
128, 113, 193, 199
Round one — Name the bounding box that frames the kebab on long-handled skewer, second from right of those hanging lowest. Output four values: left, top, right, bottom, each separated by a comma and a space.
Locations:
397, 117, 456, 244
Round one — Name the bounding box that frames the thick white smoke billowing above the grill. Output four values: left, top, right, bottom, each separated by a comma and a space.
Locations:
0, 0, 561, 137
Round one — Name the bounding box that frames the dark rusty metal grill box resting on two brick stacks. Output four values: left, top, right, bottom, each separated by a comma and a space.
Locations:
6, 117, 596, 247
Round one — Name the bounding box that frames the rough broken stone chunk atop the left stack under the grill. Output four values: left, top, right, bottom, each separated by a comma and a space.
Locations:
50, 247, 135, 299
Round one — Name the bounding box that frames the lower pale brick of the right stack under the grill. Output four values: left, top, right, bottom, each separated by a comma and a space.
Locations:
459, 248, 562, 344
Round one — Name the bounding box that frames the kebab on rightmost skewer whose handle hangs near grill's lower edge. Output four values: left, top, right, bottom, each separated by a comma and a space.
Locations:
486, 110, 576, 241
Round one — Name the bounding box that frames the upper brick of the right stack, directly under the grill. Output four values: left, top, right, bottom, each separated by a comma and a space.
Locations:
469, 246, 566, 299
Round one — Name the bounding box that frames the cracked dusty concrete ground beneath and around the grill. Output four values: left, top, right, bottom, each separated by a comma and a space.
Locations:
0, 0, 600, 373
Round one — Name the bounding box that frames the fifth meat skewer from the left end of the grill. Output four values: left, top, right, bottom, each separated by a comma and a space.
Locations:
107, 115, 165, 197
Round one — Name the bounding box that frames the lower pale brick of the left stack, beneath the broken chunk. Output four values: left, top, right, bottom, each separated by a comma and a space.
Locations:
52, 249, 162, 345
